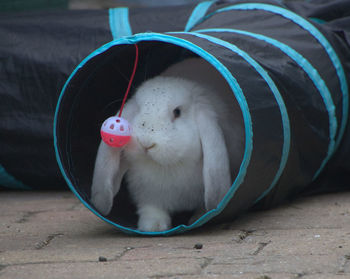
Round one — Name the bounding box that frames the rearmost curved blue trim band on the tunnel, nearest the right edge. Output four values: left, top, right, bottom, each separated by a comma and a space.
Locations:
203, 3, 349, 180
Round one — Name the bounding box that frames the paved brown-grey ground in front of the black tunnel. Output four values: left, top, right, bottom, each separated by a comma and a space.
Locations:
0, 192, 350, 279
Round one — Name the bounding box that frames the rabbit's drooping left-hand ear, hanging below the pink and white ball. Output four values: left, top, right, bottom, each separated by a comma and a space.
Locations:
91, 141, 128, 215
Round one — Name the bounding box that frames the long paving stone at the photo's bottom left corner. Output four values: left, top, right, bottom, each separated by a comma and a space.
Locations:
0, 259, 201, 279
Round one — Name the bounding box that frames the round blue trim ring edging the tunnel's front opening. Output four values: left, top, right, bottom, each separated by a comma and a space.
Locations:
53, 33, 253, 235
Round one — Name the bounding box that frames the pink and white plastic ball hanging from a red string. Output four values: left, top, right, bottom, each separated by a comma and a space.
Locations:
101, 116, 131, 147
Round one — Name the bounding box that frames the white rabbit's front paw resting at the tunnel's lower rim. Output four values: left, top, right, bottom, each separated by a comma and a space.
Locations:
137, 206, 171, 232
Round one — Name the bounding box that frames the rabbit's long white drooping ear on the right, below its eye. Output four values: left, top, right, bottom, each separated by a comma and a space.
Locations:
195, 103, 231, 210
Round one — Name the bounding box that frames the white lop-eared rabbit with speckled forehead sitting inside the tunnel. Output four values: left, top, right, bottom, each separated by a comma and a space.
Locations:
91, 58, 244, 231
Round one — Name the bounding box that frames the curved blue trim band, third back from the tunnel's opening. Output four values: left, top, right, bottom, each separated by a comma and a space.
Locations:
196, 28, 337, 195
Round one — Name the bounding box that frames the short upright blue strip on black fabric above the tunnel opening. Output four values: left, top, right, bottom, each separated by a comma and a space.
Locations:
109, 7, 132, 40
